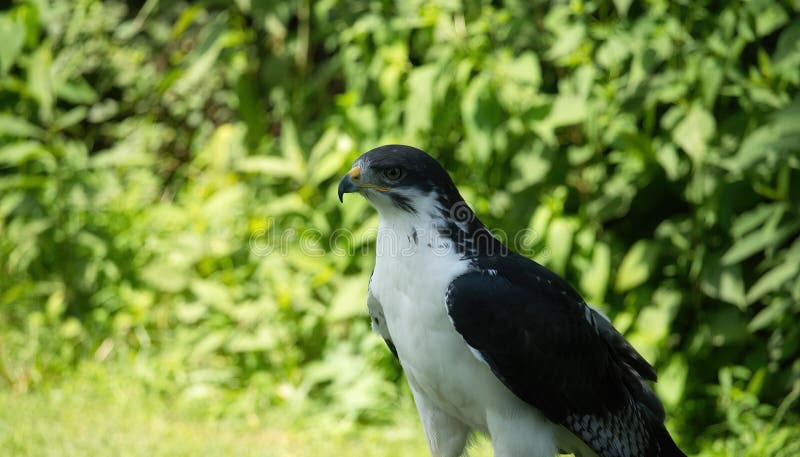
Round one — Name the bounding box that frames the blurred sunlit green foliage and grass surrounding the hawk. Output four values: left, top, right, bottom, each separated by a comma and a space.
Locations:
0, 0, 800, 456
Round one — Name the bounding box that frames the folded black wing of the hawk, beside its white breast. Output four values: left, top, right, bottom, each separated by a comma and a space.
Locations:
446, 254, 683, 457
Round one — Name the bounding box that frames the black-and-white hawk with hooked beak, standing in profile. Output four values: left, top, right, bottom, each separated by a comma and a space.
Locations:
338, 144, 685, 457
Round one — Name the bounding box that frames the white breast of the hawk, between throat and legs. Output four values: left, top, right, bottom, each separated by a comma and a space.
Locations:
370, 214, 507, 430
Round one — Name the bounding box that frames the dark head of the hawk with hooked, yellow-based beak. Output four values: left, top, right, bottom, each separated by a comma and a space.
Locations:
339, 145, 463, 213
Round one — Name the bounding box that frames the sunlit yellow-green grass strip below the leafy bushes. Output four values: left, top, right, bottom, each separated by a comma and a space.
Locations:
0, 365, 491, 457
